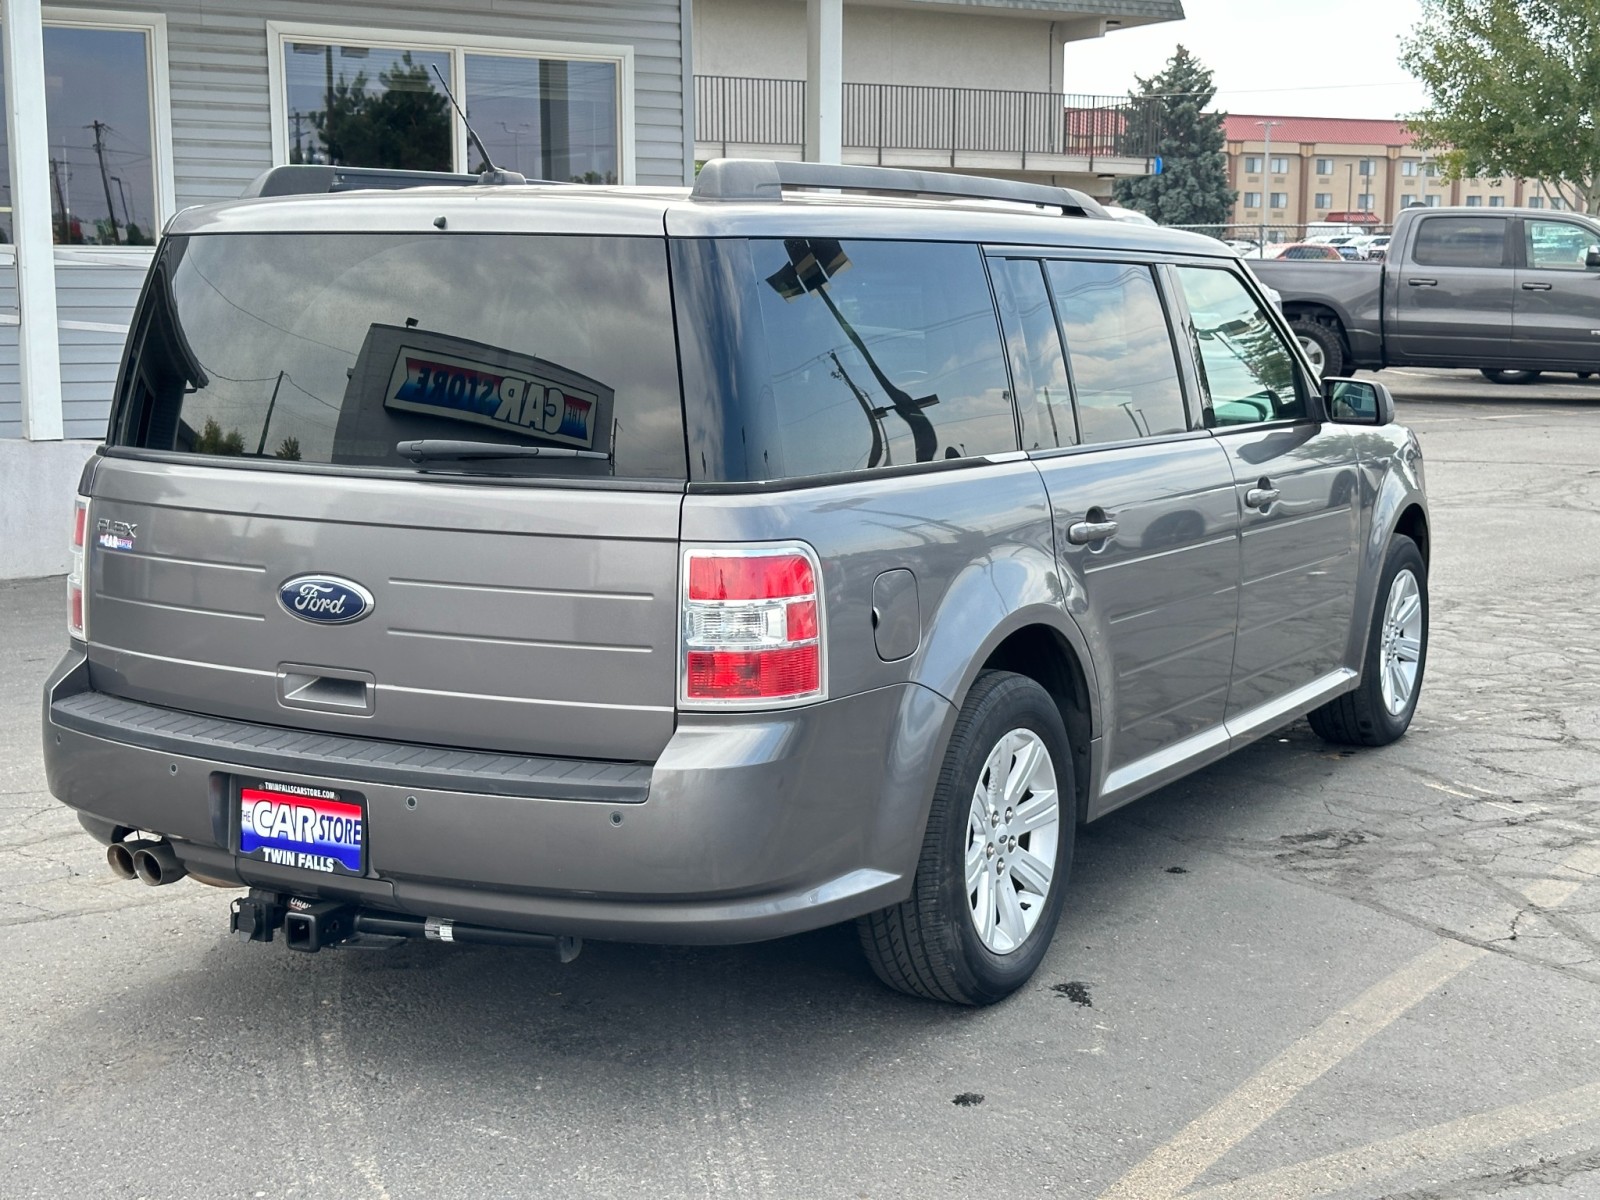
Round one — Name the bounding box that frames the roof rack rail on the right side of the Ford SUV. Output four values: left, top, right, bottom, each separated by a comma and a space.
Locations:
693, 158, 1110, 219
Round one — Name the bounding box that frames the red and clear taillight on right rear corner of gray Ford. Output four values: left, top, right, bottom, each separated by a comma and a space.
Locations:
678, 542, 827, 709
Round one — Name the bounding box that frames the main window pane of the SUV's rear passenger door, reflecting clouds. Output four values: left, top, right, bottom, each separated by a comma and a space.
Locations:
1045, 259, 1189, 443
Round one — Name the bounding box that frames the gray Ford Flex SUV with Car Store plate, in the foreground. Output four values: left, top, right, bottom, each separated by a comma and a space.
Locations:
43, 162, 1430, 1005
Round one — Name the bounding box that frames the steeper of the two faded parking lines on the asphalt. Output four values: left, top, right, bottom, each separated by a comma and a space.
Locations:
1101, 844, 1600, 1200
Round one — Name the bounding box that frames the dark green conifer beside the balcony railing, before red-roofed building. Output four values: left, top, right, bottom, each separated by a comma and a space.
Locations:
1115, 46, 1235, 226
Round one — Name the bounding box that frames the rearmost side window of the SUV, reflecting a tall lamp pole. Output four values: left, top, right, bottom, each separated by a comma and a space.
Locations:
747, 238, 1018, 478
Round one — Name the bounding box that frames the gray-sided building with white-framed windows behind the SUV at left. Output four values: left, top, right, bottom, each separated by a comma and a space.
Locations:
0, 0, 693, 579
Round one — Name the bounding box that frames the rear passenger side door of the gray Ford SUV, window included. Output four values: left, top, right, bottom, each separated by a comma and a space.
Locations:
990, 254, 1238, 805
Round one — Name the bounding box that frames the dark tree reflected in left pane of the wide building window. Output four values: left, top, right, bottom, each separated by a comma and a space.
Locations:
310, 53, 451, 171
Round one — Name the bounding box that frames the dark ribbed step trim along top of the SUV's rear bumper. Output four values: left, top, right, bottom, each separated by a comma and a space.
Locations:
50, 691, 651, 805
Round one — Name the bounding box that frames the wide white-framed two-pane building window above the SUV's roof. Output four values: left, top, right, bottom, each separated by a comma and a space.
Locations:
269, 22, 632, 184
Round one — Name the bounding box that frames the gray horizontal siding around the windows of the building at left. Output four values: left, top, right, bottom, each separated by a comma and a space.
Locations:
0, 0, 685, 438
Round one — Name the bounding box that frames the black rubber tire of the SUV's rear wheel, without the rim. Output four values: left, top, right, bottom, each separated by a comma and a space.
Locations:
856, 670, 1077, 1005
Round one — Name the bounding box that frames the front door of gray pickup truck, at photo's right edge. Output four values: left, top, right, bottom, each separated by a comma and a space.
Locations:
1512, 216, 1600, 371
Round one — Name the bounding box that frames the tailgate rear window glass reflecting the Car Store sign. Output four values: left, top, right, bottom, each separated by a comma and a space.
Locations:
112, 234, 685, 480
